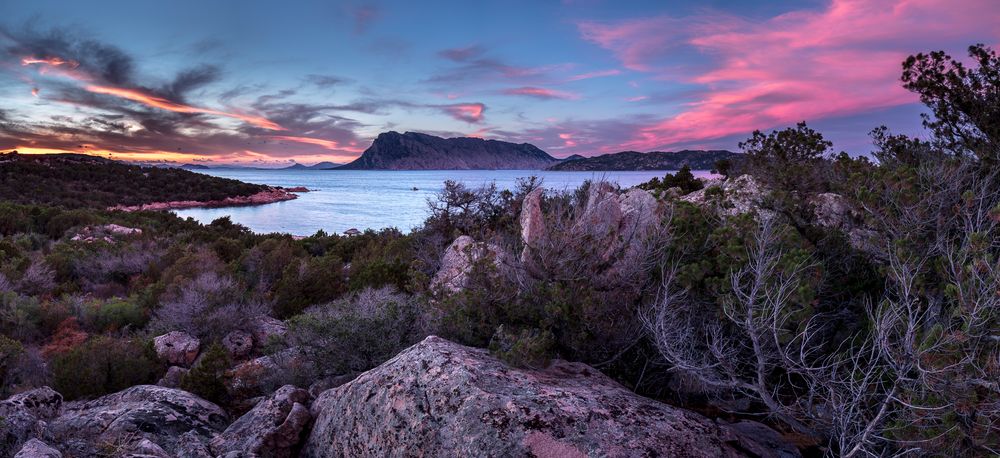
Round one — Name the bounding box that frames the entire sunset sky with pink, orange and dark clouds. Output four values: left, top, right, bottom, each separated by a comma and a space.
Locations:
0, 0, 1000, 166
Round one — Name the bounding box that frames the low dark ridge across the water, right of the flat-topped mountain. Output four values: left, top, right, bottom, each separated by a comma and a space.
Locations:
546, 150, 741, 171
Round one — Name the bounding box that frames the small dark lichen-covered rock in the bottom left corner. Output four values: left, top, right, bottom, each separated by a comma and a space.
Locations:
0, 386, 63, 456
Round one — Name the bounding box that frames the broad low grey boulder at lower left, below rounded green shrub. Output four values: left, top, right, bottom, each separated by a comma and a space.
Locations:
48, 385, 228, 456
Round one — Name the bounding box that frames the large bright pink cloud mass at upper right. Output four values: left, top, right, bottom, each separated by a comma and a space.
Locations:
578, 0, 1000, 149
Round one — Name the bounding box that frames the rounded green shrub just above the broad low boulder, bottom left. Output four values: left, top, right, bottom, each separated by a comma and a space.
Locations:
50, 336, 164, 400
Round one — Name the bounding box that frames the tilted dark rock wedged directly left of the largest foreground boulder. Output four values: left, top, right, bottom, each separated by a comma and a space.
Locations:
210, 385, 312, 457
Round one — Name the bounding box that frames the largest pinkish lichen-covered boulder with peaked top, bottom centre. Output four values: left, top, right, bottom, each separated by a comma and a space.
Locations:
303, 336, 794, 457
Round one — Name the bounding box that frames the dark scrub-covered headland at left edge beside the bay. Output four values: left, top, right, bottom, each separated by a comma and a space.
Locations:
0, 153, 269, 208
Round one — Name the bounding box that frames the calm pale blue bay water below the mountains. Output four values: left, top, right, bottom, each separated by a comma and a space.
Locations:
176, 170, 708, 235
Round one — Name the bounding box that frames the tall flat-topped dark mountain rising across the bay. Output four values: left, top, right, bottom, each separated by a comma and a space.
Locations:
337, 132, 558, 170
